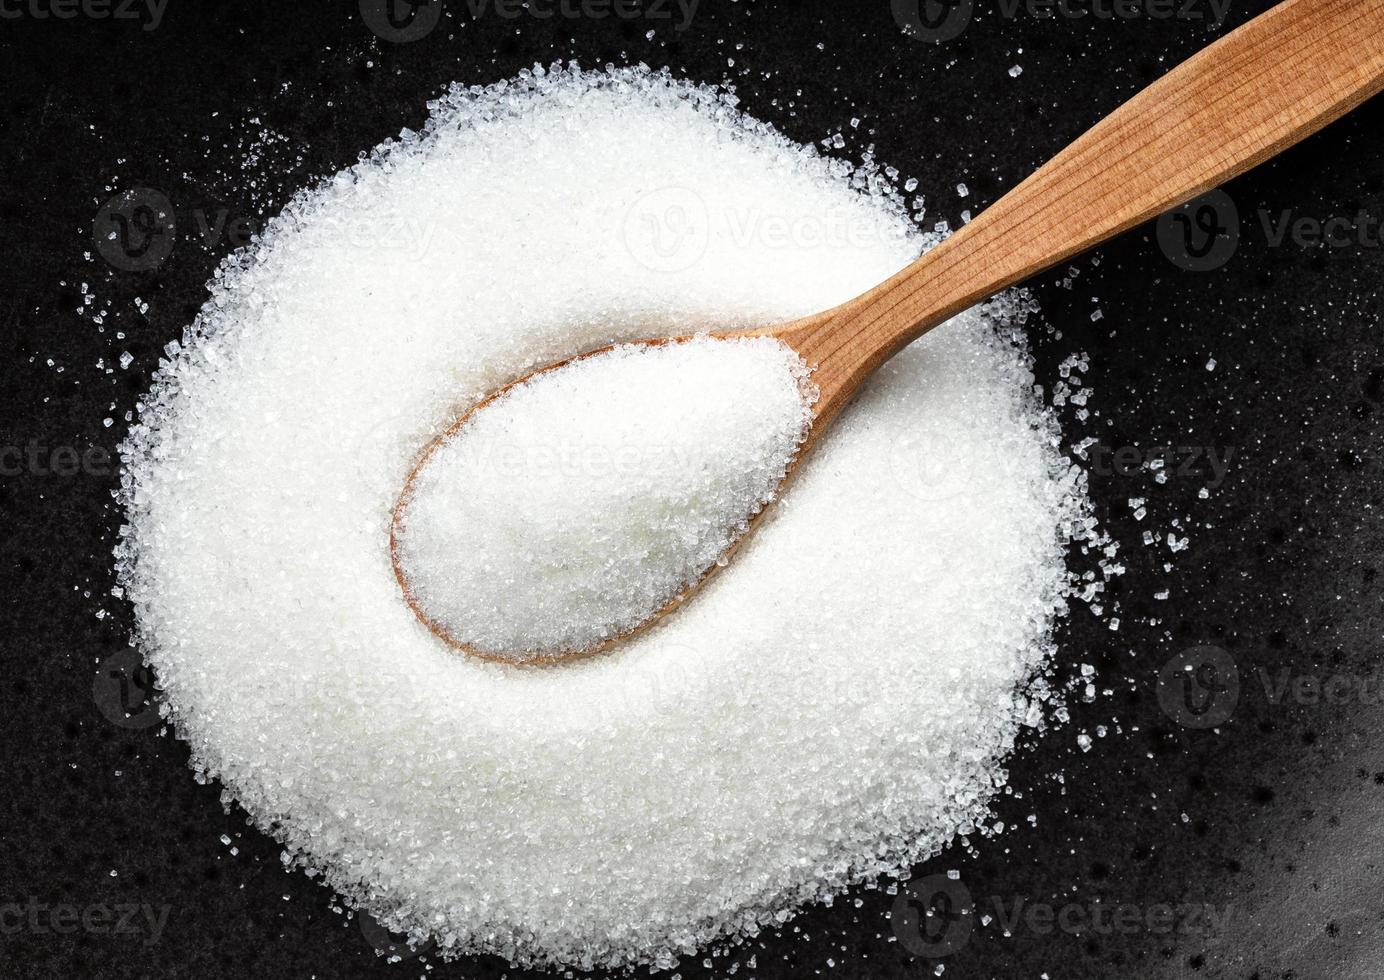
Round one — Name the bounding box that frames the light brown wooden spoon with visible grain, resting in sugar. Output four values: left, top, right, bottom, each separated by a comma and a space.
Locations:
390, 0, 1384, 660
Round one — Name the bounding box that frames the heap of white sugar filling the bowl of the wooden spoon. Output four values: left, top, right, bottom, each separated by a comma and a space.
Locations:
396, 338, 811, 660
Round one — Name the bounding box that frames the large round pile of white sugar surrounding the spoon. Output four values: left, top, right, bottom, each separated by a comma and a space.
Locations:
118, 69, 1099, 968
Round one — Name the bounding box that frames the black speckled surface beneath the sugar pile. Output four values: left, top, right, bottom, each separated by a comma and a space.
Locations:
0, 0, 1384, 980
